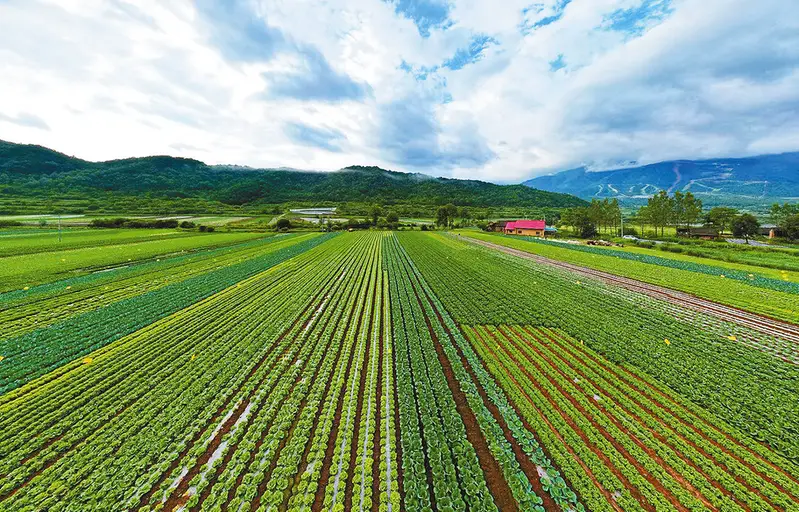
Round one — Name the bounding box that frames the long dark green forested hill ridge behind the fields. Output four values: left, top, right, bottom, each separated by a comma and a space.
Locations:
0, 141, 584, 208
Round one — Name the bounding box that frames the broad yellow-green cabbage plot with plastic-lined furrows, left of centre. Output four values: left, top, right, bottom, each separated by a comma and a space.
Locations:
0, 237, 396, 510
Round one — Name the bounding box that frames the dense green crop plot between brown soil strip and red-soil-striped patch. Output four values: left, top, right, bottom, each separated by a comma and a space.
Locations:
398, 233, 799, 460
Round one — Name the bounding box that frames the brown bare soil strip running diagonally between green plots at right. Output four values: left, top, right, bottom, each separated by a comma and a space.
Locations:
465, 237, 799, 348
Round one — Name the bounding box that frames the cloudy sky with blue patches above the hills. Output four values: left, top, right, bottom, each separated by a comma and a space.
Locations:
0, 0, 799, 182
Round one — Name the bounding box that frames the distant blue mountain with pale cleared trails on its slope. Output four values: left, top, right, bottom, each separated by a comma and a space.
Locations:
524, 153, 799, 205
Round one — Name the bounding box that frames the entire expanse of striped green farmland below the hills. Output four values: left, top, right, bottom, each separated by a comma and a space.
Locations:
0, 230, 799, 512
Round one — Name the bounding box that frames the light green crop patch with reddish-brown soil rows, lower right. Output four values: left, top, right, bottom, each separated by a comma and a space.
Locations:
467, 326, 799, 510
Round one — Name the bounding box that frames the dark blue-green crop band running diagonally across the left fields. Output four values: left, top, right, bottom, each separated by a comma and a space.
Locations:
0, 235, 335, 393
